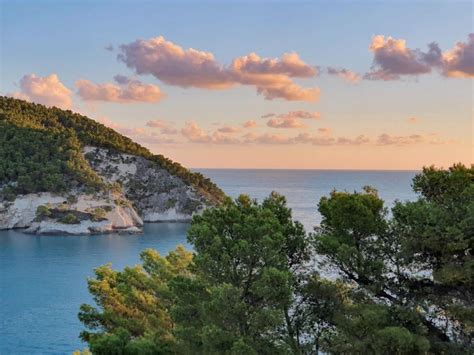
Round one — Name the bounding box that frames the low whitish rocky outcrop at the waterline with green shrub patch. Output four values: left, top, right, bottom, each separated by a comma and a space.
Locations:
0, 191, 143, 234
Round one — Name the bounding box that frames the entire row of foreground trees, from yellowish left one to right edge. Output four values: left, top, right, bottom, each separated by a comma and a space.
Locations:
79, 165, 474, 354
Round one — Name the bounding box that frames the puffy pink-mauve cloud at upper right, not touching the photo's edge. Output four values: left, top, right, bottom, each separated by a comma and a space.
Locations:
365, 35, 432, 80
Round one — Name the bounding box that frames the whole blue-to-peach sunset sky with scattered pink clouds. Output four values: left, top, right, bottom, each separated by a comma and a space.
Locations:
0, 0, 474, 170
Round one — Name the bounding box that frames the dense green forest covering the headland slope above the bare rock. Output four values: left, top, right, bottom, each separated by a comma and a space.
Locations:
0, 96, 224, 202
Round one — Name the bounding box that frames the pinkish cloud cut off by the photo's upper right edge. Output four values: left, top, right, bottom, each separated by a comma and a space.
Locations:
442, 33, 474, 78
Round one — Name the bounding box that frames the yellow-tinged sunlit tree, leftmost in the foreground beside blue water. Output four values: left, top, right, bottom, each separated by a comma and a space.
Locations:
79, 246, 192, 354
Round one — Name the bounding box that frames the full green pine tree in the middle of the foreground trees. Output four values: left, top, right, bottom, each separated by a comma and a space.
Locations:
173, 193, 310, 354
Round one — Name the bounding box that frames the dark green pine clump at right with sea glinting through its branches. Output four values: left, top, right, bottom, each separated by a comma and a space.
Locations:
315, 165, 474, 353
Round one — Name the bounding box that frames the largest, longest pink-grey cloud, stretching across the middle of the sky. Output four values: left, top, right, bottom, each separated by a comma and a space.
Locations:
117, 36, 320, 101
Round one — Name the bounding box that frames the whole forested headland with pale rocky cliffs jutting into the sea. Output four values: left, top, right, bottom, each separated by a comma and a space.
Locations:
0, 97, 225, 235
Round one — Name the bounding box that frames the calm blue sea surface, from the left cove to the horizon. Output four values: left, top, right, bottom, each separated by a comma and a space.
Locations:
0, 169, 416, 355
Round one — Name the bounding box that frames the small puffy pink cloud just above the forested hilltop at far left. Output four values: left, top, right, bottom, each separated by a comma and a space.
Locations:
9, 74, 72, 109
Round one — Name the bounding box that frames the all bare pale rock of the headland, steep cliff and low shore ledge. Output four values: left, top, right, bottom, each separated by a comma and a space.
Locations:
0, 147, 209, 234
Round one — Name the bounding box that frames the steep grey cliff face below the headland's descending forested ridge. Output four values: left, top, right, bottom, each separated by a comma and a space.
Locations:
84, 147, 208, 222
